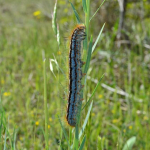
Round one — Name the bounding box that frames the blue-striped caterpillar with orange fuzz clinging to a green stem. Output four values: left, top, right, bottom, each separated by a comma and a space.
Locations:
66, 25, 86, 127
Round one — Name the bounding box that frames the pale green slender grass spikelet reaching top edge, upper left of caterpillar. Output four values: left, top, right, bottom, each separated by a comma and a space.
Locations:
52, 0, 57, 35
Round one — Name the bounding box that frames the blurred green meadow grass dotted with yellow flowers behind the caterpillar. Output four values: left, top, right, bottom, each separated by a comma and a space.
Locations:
0, 0, 150, 150
